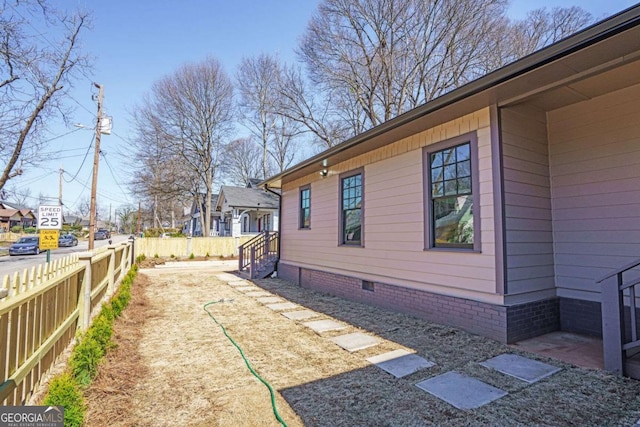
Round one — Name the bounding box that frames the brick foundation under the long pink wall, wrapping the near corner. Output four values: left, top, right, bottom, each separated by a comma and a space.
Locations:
278, 263, 560, 343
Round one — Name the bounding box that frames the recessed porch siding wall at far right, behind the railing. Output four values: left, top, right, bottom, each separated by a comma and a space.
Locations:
548, 85, 640, 301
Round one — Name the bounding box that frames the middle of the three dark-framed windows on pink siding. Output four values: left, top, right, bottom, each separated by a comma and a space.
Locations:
340, 171, 363, 246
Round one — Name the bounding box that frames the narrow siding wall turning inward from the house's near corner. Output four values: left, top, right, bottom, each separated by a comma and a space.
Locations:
500, 108, 555, 303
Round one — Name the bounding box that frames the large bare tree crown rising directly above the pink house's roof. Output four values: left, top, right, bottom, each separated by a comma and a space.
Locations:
280, 0, 591, 146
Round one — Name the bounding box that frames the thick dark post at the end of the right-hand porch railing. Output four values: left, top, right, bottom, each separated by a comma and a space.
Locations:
601, 273, 624, 375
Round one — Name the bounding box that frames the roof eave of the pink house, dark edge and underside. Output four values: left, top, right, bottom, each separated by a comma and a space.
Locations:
260, 5, 640, 188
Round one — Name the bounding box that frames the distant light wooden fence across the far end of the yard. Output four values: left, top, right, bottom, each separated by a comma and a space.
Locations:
134, 235, 254, 258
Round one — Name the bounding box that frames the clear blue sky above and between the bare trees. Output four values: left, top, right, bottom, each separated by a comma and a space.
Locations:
10, 0, 635, 219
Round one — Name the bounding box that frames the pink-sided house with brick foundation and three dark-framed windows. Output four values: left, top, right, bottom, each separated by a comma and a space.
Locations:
262, 6, 640, 354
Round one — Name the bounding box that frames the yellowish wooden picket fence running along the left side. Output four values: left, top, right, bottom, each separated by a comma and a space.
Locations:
0, 243, 132, 405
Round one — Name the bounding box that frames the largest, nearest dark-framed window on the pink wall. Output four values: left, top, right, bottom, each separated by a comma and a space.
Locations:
425, 139, 479, 249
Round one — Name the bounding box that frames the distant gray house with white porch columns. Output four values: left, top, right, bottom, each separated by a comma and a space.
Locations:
215, 184, 279, 237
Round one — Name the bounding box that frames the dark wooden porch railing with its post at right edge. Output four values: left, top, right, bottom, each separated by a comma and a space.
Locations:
597, 259, 640, 376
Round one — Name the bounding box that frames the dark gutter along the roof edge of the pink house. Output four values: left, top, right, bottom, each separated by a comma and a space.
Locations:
260, 2, 640, 186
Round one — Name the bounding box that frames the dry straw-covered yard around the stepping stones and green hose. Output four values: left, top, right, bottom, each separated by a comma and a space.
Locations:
86, 268, 640, 427
